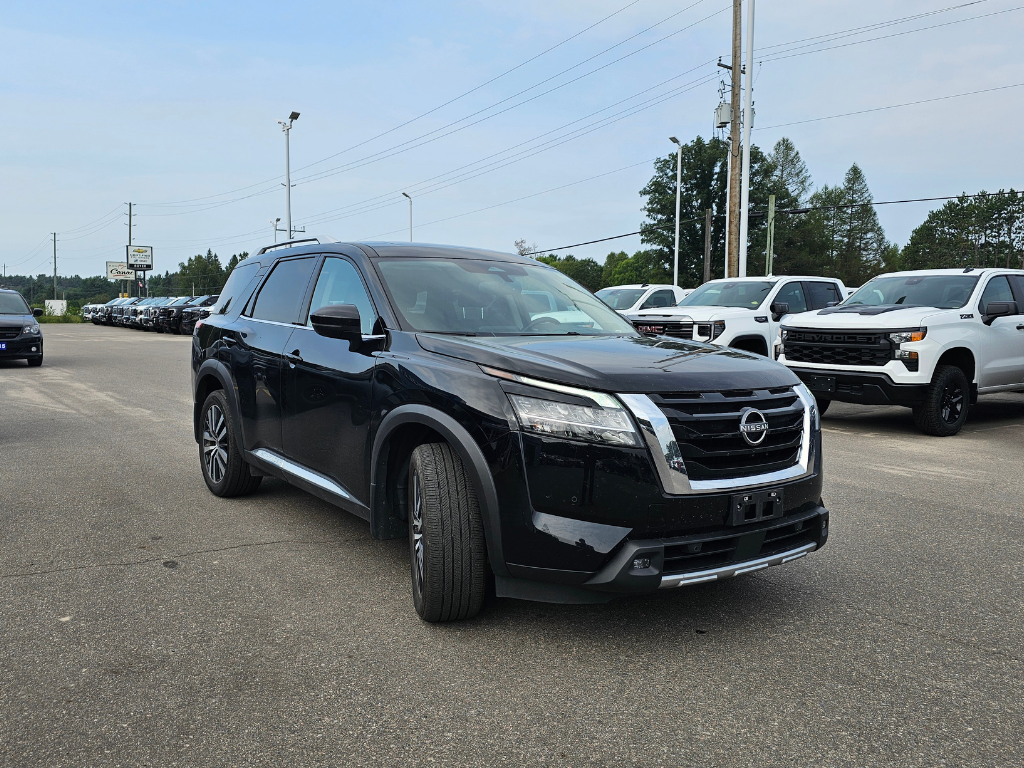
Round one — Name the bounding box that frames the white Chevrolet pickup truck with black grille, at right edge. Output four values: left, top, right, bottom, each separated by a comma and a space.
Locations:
779, 267, 1024, 436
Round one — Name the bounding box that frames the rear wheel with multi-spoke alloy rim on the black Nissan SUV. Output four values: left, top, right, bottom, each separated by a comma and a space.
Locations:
199, 389, 263, 497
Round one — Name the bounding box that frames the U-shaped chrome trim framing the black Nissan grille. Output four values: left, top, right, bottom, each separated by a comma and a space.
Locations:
618, 384, 815, 496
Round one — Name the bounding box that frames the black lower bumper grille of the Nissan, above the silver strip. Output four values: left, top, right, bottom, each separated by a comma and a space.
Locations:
662, 515, 821, 575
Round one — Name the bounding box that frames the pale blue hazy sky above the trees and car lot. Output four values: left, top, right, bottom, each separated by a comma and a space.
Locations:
0, 0, 1024, 274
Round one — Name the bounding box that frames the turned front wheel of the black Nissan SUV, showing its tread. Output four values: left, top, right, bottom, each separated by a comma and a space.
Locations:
409, 442, 487, 622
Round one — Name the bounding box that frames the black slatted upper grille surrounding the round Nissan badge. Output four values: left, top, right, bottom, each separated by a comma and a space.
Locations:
650, 387, 804, 480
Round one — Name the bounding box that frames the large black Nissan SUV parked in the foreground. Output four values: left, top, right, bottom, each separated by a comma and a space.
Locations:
193, 243, 828, 621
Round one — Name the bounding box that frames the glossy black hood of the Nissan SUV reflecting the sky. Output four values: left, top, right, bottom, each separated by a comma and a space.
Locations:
416, 334, 799, 393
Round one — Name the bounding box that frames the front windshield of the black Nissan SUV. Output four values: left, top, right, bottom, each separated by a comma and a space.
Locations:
378, 258, 636, 336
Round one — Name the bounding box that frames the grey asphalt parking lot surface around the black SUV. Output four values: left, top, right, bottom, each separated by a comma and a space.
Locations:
0, 326, 1024, 767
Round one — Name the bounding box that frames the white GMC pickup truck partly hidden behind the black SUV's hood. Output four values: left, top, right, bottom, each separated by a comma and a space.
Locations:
626, 276, 844, 357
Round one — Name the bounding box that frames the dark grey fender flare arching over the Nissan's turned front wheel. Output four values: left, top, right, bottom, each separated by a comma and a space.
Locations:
370, 403, 509, 575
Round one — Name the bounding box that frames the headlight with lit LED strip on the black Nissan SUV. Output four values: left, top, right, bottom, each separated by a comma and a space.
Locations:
480, 366, 641, 447
